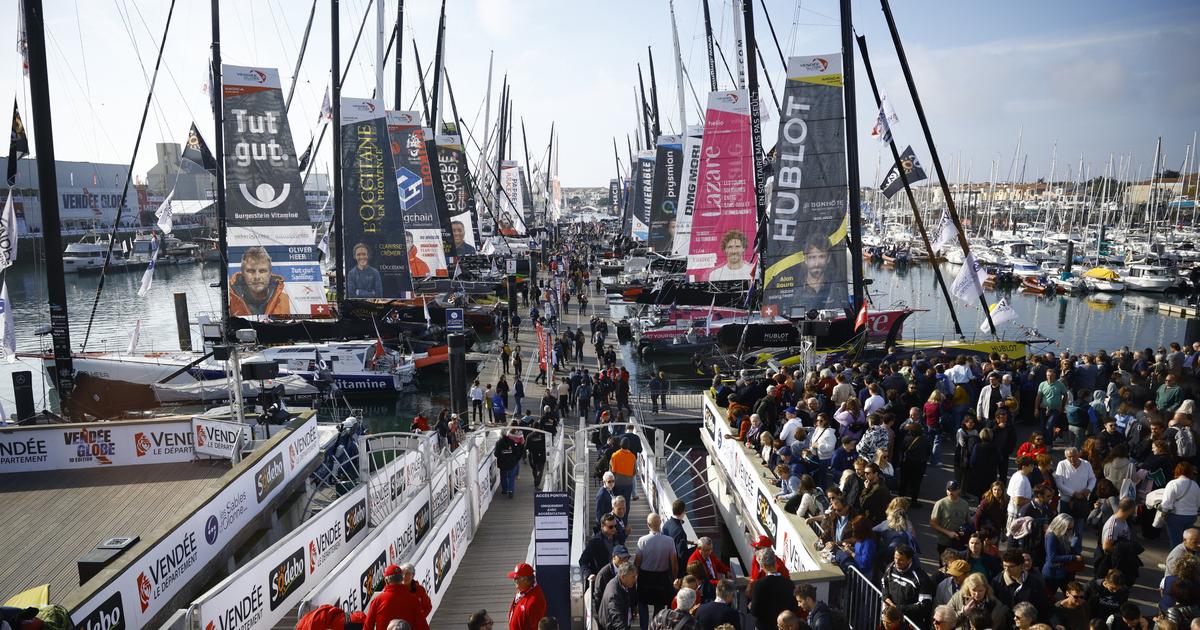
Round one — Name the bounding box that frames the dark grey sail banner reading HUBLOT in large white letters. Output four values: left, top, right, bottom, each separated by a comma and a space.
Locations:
763, 53, 848, 316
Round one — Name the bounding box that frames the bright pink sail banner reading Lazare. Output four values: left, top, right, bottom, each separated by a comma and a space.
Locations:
688, 90, 757, 282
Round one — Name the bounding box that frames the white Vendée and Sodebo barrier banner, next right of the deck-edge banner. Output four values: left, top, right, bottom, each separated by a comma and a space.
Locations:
192, 486, 367, 630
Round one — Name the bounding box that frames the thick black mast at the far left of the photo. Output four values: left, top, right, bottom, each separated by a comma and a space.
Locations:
22, 0, 73, 416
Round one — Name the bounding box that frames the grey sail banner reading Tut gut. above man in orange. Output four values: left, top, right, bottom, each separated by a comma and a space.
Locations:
222, 65, 328, 319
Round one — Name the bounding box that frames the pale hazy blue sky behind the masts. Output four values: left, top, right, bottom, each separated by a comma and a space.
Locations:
0, 0, 1200, 187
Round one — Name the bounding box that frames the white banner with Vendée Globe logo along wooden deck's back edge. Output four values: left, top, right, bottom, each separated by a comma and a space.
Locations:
0, 420, 194, 473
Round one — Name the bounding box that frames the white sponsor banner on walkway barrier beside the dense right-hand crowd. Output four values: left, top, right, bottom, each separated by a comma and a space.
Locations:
704, 396, 829, 571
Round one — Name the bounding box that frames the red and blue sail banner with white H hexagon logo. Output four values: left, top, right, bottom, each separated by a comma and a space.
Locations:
386, 112, 446, 278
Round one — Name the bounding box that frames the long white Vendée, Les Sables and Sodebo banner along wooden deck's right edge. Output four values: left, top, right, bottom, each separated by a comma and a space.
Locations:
71, 415, 320, 628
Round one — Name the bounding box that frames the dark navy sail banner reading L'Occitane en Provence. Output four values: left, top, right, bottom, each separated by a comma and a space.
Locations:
341, 98, 417, 299
